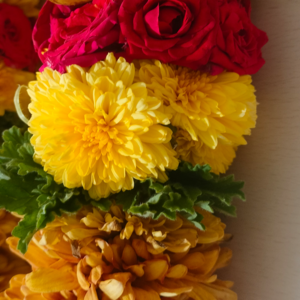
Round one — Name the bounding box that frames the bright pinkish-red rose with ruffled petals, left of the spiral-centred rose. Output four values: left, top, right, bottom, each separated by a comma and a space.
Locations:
33, 0, 122, 73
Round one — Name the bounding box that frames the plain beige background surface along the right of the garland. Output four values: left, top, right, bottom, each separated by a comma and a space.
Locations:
220, 0, 300, 300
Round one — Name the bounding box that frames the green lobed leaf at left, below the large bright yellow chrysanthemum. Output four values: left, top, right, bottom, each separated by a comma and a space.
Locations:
0, 127, 88, 253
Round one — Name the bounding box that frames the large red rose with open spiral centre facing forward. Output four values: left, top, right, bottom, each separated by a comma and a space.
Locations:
119, 0, 218, 69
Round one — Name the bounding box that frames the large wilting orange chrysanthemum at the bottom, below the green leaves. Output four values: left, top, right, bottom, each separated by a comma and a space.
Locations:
0, 206, 237, 300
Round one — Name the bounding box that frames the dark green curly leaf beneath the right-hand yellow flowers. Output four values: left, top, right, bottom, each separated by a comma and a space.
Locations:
112, 162, 245, 230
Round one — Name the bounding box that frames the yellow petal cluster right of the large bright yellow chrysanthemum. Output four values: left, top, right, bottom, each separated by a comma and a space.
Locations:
135, 60, 257, 173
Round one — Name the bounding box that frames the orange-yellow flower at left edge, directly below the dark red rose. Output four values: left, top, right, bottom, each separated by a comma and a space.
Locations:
0, 62, 35, 116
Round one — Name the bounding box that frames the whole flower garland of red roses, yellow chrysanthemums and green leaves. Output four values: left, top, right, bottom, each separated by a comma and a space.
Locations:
0, 0, 268, 300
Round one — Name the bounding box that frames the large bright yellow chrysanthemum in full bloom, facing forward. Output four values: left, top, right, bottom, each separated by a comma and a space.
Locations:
28, 54, 178, 199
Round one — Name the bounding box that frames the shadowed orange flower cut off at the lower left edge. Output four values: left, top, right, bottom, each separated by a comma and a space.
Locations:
0, 209, 30, 292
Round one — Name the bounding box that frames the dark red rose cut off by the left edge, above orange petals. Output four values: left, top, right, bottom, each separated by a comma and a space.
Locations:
0, 3, 35, 69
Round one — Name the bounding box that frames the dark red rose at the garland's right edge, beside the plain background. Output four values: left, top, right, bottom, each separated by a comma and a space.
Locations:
210, 0, 268, 75
